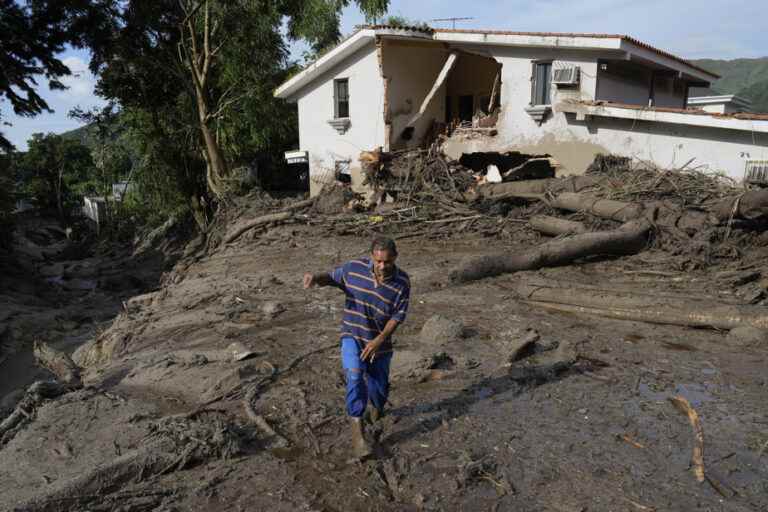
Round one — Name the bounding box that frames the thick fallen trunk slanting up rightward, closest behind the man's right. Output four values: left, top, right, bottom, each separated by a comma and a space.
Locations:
449, 221, 650, 283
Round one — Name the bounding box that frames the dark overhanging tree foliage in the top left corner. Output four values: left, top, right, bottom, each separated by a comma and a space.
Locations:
0, 0, 109, 153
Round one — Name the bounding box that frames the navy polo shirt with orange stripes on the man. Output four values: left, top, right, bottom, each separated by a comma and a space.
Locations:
330, 258, 411, 352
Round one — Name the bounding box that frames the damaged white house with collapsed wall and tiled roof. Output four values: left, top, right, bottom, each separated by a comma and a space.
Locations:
275, 25, 768, 195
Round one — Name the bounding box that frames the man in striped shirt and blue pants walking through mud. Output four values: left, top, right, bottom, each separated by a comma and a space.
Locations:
304, 238, 411, 459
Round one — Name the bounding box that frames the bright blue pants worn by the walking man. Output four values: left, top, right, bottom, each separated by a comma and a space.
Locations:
341, 337, 392, 418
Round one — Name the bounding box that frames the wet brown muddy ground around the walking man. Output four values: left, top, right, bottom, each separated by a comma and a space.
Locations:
0, 214, 768, 512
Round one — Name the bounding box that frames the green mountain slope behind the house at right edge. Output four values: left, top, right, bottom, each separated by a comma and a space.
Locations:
690, 57, 768, 112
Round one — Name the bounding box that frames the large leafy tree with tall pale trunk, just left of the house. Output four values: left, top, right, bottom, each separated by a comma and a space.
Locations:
92, 0, 388, 207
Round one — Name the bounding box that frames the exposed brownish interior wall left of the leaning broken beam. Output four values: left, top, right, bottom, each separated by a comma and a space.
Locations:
382, 40, 450, 149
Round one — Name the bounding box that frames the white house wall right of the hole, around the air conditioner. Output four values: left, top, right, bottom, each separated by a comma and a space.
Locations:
444, 47, 768, 180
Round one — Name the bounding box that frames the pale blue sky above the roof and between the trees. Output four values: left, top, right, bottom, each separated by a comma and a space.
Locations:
0, 0, 768, 151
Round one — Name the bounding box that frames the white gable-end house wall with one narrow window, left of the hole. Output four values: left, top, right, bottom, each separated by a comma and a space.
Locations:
298, 42, 385, 195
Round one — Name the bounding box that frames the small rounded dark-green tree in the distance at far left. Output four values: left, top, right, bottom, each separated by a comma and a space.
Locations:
19, 133, 97, 219
